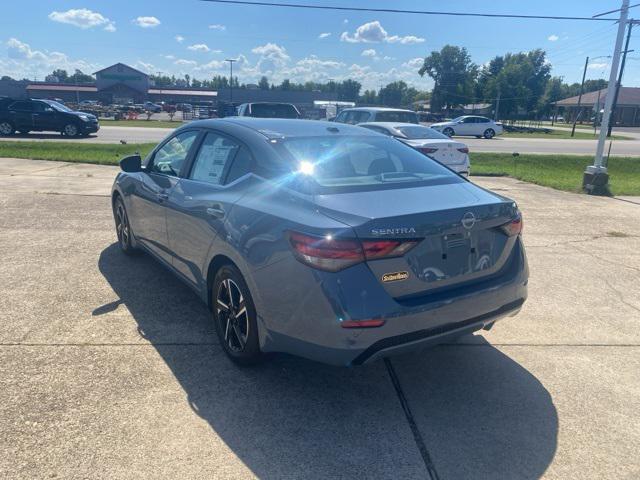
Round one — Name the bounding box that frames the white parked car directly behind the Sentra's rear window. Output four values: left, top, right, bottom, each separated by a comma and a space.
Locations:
358, 122, 471, 177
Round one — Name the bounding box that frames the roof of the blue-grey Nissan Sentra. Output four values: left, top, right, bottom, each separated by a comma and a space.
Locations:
181, 117, 377, 139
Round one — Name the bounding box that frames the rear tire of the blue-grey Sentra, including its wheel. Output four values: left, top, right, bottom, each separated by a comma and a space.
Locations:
211, 264, 264, 365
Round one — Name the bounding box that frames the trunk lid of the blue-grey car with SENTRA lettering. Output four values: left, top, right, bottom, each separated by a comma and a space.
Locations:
315, 182, 518, 298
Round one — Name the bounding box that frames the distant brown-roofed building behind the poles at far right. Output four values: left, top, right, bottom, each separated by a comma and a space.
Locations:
554, 87, 640, 127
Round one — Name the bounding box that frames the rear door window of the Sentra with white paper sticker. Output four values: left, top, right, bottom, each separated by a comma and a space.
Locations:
189, 132, 240, 185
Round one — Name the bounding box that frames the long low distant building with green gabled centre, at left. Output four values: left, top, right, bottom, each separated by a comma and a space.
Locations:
0, 63, 337, 110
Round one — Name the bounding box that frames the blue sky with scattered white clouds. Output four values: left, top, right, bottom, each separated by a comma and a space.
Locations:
0, 0, 640, 90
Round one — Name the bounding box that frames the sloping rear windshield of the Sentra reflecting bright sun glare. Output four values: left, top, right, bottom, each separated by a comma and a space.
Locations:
277, 136, 464, 193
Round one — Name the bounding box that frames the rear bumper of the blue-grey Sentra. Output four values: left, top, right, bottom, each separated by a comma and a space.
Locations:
256, 238, 528, 365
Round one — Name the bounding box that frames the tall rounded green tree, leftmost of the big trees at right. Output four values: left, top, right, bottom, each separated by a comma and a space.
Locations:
418, 45, 478, 111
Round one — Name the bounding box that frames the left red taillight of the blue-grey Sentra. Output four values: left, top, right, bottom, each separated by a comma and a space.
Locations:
289, 232, 418, 272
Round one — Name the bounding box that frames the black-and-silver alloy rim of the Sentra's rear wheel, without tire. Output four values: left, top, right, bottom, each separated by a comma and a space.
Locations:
216, 278, 250, 352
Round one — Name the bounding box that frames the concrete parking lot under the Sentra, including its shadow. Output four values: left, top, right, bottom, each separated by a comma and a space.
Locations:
0, 159, 640, 480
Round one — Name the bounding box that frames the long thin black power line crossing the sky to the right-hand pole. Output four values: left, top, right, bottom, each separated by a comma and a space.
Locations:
201, 0, 618, 22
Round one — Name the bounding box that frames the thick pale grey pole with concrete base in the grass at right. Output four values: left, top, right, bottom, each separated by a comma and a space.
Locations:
582, 0, 629, 195
